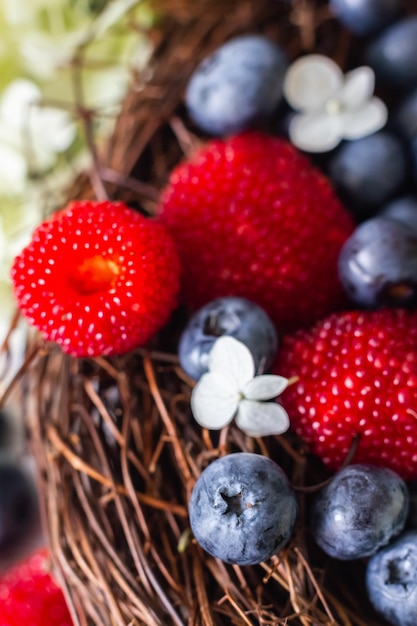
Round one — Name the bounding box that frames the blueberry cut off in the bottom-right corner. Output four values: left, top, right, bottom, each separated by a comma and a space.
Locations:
366, 530, 417, 626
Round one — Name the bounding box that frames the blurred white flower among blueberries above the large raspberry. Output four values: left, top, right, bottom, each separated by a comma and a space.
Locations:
284, 54, 388, 152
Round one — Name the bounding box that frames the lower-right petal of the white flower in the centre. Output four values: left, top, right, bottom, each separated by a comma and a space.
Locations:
236, 400, 290, 437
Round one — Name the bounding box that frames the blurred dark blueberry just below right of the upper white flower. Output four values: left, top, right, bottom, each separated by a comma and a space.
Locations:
329, 131, 407, 213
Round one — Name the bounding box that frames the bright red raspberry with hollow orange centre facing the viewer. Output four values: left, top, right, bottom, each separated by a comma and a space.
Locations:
12, 201, 179, 356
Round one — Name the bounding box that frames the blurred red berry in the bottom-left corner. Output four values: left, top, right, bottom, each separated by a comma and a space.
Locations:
0, 550, 73, 626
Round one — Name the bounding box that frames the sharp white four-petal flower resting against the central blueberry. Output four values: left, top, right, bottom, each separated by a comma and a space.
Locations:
191, 336, 289, 437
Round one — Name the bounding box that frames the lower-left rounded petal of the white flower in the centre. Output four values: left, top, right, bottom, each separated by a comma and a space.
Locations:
191, 372, 239, 430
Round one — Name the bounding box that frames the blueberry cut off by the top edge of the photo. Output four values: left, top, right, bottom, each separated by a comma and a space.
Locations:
329, 0, 402, 35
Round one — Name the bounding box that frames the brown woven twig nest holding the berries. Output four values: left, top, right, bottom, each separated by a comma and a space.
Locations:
8, 0, 414, 626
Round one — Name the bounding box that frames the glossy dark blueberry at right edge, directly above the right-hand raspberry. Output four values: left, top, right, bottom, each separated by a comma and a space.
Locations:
339, 216, 417, 309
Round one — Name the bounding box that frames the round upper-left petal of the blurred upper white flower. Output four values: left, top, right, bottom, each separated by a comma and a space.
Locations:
284, 54, 343, 112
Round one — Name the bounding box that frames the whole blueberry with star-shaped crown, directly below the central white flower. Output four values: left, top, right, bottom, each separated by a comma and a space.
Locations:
189, 452, 297, 565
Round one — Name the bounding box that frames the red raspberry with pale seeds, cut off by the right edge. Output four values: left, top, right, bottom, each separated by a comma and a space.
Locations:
275, 309, 417, 480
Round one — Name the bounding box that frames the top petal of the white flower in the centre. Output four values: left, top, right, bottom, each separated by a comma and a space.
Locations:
208, 336, 255, 391
